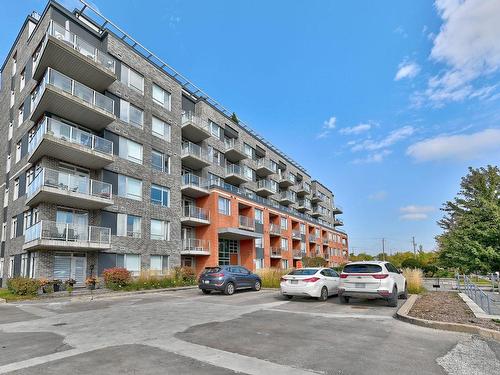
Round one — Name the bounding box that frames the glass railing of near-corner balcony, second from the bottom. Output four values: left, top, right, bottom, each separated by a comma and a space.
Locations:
26, 168, 112, 199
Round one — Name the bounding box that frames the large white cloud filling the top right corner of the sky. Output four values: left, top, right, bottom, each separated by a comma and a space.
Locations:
420, 0, 500, 106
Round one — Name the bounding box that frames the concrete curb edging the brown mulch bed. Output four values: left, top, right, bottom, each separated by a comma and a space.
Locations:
396, 294, 500, 341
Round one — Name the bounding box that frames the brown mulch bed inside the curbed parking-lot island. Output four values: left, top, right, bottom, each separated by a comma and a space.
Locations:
408, 292, 500, 331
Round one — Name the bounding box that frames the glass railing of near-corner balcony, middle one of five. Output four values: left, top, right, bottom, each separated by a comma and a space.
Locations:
28, 117, 113, 156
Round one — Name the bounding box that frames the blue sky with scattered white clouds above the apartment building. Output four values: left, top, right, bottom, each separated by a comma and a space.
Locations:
0, 0, 500, 253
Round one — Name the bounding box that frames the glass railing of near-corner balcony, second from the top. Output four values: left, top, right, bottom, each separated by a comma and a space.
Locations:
31, 68, 115, 115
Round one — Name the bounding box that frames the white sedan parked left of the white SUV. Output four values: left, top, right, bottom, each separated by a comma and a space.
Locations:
280, 268, 340, 301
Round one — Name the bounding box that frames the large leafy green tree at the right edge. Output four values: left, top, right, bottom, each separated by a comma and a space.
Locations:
436, 165, 500, 273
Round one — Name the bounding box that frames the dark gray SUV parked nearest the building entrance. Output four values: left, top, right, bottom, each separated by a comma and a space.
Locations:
198, 266, 262, 295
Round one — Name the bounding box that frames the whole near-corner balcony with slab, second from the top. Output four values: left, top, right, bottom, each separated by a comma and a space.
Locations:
30, 68, 116, 131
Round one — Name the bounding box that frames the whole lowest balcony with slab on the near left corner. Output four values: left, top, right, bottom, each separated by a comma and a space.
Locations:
23, 220, 111, 250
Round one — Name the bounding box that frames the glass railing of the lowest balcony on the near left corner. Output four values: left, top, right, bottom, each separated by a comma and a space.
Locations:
24, 220, 111, 244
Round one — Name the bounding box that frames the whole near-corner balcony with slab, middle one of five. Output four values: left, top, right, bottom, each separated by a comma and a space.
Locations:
28, 117, 113, 169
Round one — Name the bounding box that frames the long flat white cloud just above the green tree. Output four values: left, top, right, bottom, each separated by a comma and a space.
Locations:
406, 129, 500, 161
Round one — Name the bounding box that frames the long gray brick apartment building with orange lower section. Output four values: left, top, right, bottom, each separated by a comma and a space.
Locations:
0, 1, 348, 285
